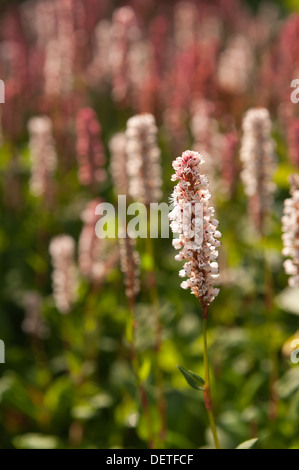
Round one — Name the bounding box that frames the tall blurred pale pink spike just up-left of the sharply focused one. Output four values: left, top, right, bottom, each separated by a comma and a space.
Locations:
126, 114, 162, 204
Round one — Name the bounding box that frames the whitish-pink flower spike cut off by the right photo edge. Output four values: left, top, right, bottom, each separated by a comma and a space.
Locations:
282, 174, 299, 287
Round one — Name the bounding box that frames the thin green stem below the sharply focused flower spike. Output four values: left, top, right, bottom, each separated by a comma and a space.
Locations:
203, 307, 220, 449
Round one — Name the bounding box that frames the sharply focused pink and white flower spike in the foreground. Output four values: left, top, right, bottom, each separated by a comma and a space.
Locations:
169, 150, 221, 308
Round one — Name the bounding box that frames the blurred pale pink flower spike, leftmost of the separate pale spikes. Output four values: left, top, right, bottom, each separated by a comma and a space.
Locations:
28, 116, 57, 198
